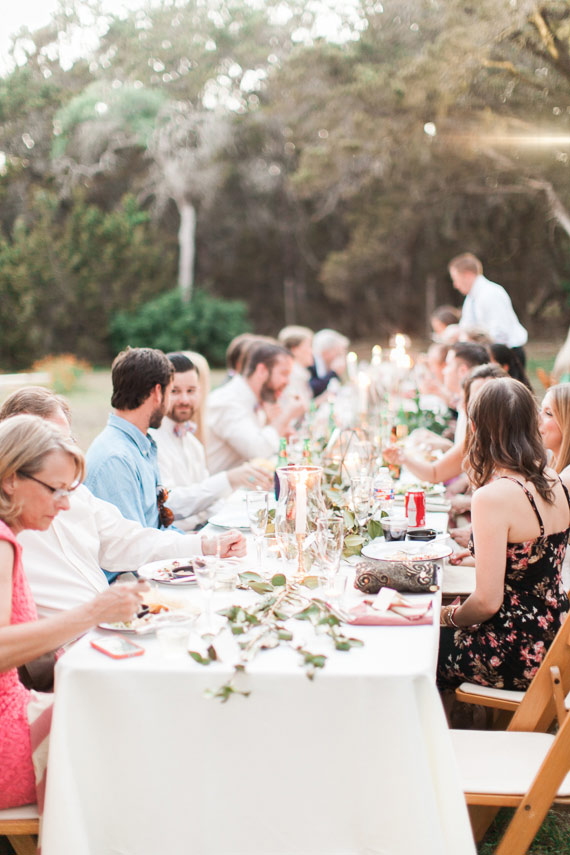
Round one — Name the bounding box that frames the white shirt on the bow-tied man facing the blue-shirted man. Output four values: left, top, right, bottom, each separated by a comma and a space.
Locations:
149, 416, 232, 531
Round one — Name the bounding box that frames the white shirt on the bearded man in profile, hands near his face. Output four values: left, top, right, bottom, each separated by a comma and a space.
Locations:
207, 374, 279, 472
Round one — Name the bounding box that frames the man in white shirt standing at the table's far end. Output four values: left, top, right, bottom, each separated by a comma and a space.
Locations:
448, 252, 528, 365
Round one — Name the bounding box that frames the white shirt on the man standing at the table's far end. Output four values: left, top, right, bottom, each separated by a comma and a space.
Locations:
459, 276, 528, 347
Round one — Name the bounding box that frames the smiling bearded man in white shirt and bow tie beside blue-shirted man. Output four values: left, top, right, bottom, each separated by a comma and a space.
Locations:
151, 353, 272, 531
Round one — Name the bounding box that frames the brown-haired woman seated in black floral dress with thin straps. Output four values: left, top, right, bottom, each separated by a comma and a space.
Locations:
437, 377, 570, 689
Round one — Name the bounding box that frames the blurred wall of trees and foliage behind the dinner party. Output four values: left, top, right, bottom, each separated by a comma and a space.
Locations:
0, 0, 570, 370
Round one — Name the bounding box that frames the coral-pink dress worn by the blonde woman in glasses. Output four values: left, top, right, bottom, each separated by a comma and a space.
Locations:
0, 520, 38, 809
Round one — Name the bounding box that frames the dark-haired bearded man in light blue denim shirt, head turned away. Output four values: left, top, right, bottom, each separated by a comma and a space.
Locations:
85, 347, 174, 528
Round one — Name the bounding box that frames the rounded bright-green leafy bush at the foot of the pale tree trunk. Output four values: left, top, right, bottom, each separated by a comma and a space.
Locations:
109, 289, 248, 366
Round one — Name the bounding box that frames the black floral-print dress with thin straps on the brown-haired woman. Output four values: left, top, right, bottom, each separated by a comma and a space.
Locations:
437, 476, 570, 690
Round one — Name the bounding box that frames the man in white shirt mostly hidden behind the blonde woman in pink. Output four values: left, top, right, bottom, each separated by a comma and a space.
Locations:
0, 386, 244, 617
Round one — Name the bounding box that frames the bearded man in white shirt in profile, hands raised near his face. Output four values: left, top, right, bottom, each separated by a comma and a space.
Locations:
206, 342, 304, 472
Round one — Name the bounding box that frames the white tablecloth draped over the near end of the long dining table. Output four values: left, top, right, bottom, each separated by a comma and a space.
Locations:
42, 504, 475, 855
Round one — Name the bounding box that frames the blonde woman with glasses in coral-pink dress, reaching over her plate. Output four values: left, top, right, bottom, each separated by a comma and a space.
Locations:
0, 416, 148, 811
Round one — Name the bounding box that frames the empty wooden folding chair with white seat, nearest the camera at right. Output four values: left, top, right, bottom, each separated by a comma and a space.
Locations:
451, 618, 570, 855
